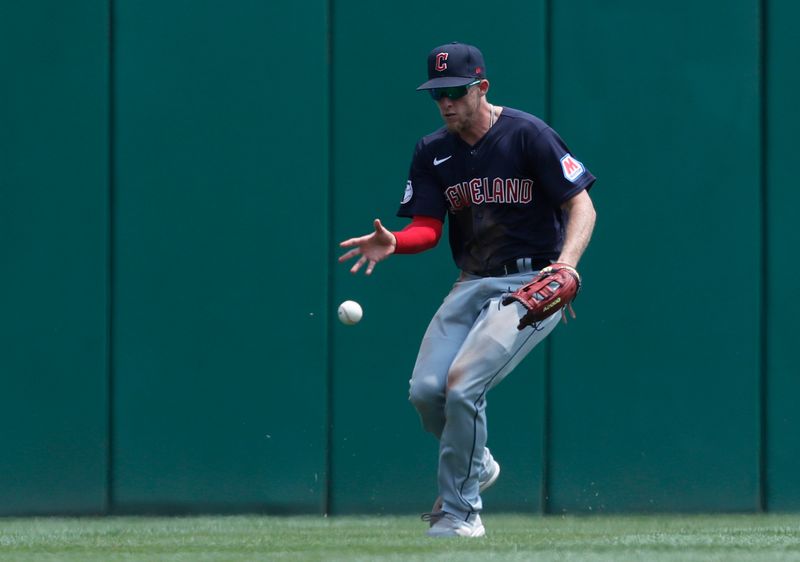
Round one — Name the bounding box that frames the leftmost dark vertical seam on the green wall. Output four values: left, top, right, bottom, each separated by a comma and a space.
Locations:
105, 0, 116, 513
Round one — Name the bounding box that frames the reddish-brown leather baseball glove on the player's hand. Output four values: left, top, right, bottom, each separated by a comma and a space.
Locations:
503, 263, 581, 330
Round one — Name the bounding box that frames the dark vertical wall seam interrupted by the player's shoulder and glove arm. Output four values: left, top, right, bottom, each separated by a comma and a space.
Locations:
539, 0, 553, 514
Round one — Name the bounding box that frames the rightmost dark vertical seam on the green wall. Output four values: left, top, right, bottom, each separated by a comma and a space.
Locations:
758, 0, 769, 512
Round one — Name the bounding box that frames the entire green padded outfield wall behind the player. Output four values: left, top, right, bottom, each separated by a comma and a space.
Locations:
0, 0, 800, 515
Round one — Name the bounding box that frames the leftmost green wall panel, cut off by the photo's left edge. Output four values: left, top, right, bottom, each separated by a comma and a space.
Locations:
0, 0, 108, 515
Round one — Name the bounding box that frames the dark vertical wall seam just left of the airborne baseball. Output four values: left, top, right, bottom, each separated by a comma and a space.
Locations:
322, 0, 335, 516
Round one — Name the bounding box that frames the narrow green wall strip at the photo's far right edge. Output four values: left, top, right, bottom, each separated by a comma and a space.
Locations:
766, 0, 800, 511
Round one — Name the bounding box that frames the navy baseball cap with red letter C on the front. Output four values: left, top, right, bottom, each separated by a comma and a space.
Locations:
417, 42, 486, 90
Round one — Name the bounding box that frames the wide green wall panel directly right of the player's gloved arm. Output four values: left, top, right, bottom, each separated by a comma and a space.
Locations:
549, 0, 761, 512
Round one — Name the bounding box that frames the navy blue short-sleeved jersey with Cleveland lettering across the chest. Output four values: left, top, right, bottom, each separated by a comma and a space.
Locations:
397, 107, 595, 273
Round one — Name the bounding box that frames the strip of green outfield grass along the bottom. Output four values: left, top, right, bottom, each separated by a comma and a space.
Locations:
0, 513, 800, 562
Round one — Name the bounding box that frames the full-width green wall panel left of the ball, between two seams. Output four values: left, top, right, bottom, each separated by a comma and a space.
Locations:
113, 0, 328, 512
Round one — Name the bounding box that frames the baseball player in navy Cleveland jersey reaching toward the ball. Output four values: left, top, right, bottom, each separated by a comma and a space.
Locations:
339, 43, 595, 537
